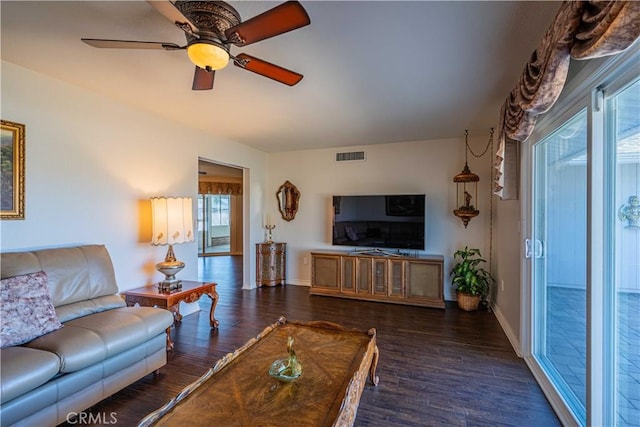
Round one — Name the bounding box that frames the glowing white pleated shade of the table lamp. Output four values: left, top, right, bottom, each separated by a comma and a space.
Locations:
151, 197, 194, 245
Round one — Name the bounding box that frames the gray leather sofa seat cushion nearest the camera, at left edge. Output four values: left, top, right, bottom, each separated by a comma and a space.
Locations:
0, 346, 60, 404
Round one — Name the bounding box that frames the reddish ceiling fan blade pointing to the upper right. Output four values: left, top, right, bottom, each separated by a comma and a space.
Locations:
225, 1, 311, 46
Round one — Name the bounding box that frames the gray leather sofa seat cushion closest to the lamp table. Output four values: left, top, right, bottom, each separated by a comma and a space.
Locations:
27, 307, 173, 373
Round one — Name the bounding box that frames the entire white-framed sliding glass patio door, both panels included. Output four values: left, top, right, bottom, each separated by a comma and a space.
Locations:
523, 48, 640, 427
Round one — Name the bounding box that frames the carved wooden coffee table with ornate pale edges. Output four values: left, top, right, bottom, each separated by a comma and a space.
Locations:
139, 318, 378, 427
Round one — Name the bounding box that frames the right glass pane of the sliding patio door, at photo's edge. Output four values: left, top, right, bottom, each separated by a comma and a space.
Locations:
606, 80, 640, 426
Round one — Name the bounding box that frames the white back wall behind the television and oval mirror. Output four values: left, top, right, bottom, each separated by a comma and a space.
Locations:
267, 137, 491, 300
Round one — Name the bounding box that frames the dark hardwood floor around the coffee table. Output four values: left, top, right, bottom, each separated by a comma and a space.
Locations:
62, 257, 560, 426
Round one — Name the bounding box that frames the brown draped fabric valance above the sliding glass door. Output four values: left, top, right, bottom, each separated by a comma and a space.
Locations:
494, 1, 640, 199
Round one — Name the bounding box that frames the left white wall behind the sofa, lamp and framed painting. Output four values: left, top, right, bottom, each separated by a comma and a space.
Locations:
0, 62, 267, 290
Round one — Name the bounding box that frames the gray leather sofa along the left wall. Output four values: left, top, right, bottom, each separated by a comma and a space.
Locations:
0, 245, 173, 426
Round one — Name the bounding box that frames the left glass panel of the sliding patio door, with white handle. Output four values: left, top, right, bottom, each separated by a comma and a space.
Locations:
527, 110, 587, 420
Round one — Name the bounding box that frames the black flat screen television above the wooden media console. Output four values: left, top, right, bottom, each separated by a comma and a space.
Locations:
332, 194, 425, 250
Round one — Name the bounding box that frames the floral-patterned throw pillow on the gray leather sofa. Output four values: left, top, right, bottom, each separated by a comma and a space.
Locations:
0, 271, 62, 348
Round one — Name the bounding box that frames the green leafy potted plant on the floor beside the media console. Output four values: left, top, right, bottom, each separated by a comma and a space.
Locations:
450, 246, 495, 311
